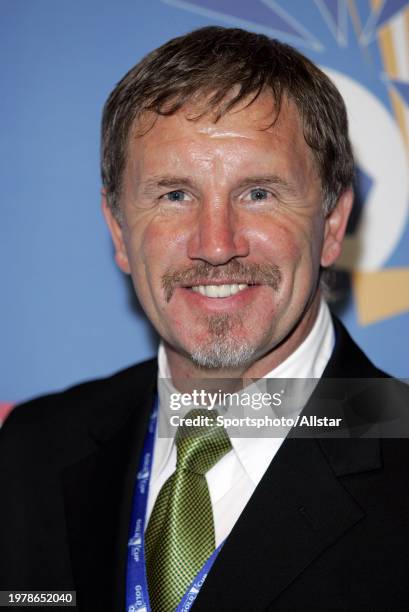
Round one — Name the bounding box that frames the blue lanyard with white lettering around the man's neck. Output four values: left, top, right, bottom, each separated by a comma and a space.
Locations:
126, 398, 223, 612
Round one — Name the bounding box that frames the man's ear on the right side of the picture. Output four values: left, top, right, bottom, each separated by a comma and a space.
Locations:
321, 187, 354, 268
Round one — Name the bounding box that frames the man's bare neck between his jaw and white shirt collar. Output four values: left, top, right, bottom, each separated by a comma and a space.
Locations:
165, 292, 321, 393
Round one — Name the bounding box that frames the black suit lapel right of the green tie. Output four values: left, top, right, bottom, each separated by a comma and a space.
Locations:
195, 439, 364, 612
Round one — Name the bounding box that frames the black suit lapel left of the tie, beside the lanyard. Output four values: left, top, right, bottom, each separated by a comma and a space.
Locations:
62, 364, 156, 611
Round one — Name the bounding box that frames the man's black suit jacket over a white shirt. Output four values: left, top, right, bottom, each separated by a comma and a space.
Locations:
0, 322, 409, 612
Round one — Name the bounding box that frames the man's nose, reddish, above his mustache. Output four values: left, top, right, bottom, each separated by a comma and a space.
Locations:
188, 202, 249, 266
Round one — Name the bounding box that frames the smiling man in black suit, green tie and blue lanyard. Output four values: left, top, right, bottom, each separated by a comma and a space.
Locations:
0, 27, 409, 612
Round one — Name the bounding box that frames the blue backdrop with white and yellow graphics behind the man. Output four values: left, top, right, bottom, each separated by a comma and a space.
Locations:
0, 0, 409, 401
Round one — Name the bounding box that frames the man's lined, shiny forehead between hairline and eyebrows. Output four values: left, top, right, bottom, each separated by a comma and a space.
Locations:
127, 94, 314, 179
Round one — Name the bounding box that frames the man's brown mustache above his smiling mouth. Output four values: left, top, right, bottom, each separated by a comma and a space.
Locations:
162, 259, 282, 302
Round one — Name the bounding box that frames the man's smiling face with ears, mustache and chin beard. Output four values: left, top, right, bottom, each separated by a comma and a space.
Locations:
105, 95, 348, 368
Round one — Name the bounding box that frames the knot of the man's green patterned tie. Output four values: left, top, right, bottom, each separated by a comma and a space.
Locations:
176, 408, 232, 475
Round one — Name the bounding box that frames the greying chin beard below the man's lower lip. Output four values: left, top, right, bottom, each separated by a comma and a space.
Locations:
190, 314, 256, 370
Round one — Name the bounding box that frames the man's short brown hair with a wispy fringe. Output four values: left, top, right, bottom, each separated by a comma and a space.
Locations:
101, 26, 354, 218
